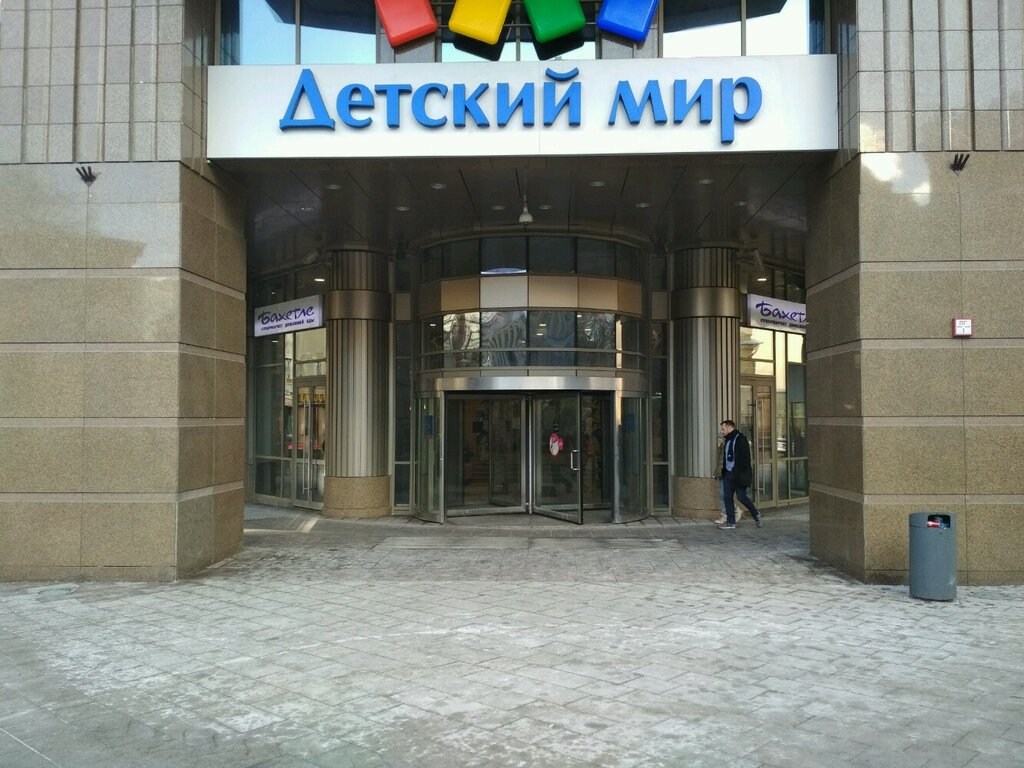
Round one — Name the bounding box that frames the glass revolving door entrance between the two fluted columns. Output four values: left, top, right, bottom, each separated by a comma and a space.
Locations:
416, 391, 647, 524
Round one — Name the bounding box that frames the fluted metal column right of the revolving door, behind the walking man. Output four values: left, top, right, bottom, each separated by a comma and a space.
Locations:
672, 246, 740, 517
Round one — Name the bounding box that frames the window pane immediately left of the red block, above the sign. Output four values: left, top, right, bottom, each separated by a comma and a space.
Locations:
299, 0, 377, 63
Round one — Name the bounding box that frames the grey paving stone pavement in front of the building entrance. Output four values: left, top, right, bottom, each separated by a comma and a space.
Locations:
0, 506, 1024, 768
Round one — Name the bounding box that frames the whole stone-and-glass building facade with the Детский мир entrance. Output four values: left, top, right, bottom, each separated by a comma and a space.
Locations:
0, 0, 1024, 584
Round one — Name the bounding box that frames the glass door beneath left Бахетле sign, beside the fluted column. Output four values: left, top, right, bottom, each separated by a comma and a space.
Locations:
292, 379, 327, 509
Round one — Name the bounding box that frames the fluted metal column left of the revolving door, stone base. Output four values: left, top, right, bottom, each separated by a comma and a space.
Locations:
324, 250, 391, 517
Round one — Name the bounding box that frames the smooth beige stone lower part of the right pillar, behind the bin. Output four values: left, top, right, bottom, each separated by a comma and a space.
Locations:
807, 153, 1024, 584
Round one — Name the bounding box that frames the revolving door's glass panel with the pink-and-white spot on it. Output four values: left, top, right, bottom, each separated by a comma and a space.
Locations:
531, 393, 583, 523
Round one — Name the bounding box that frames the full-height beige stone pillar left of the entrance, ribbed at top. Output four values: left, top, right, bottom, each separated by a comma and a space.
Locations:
0, 0, 246, 580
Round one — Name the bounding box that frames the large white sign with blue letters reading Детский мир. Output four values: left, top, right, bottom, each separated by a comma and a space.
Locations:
208, 55, 839, 159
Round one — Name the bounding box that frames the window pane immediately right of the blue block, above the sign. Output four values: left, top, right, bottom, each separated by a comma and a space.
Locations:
662, 0, 741, 58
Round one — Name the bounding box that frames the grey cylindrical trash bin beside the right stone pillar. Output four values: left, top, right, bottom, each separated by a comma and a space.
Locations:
910, 512, 956, 600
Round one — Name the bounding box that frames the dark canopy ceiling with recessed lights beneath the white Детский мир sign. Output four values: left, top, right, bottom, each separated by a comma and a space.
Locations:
224, 153, 831, 275
